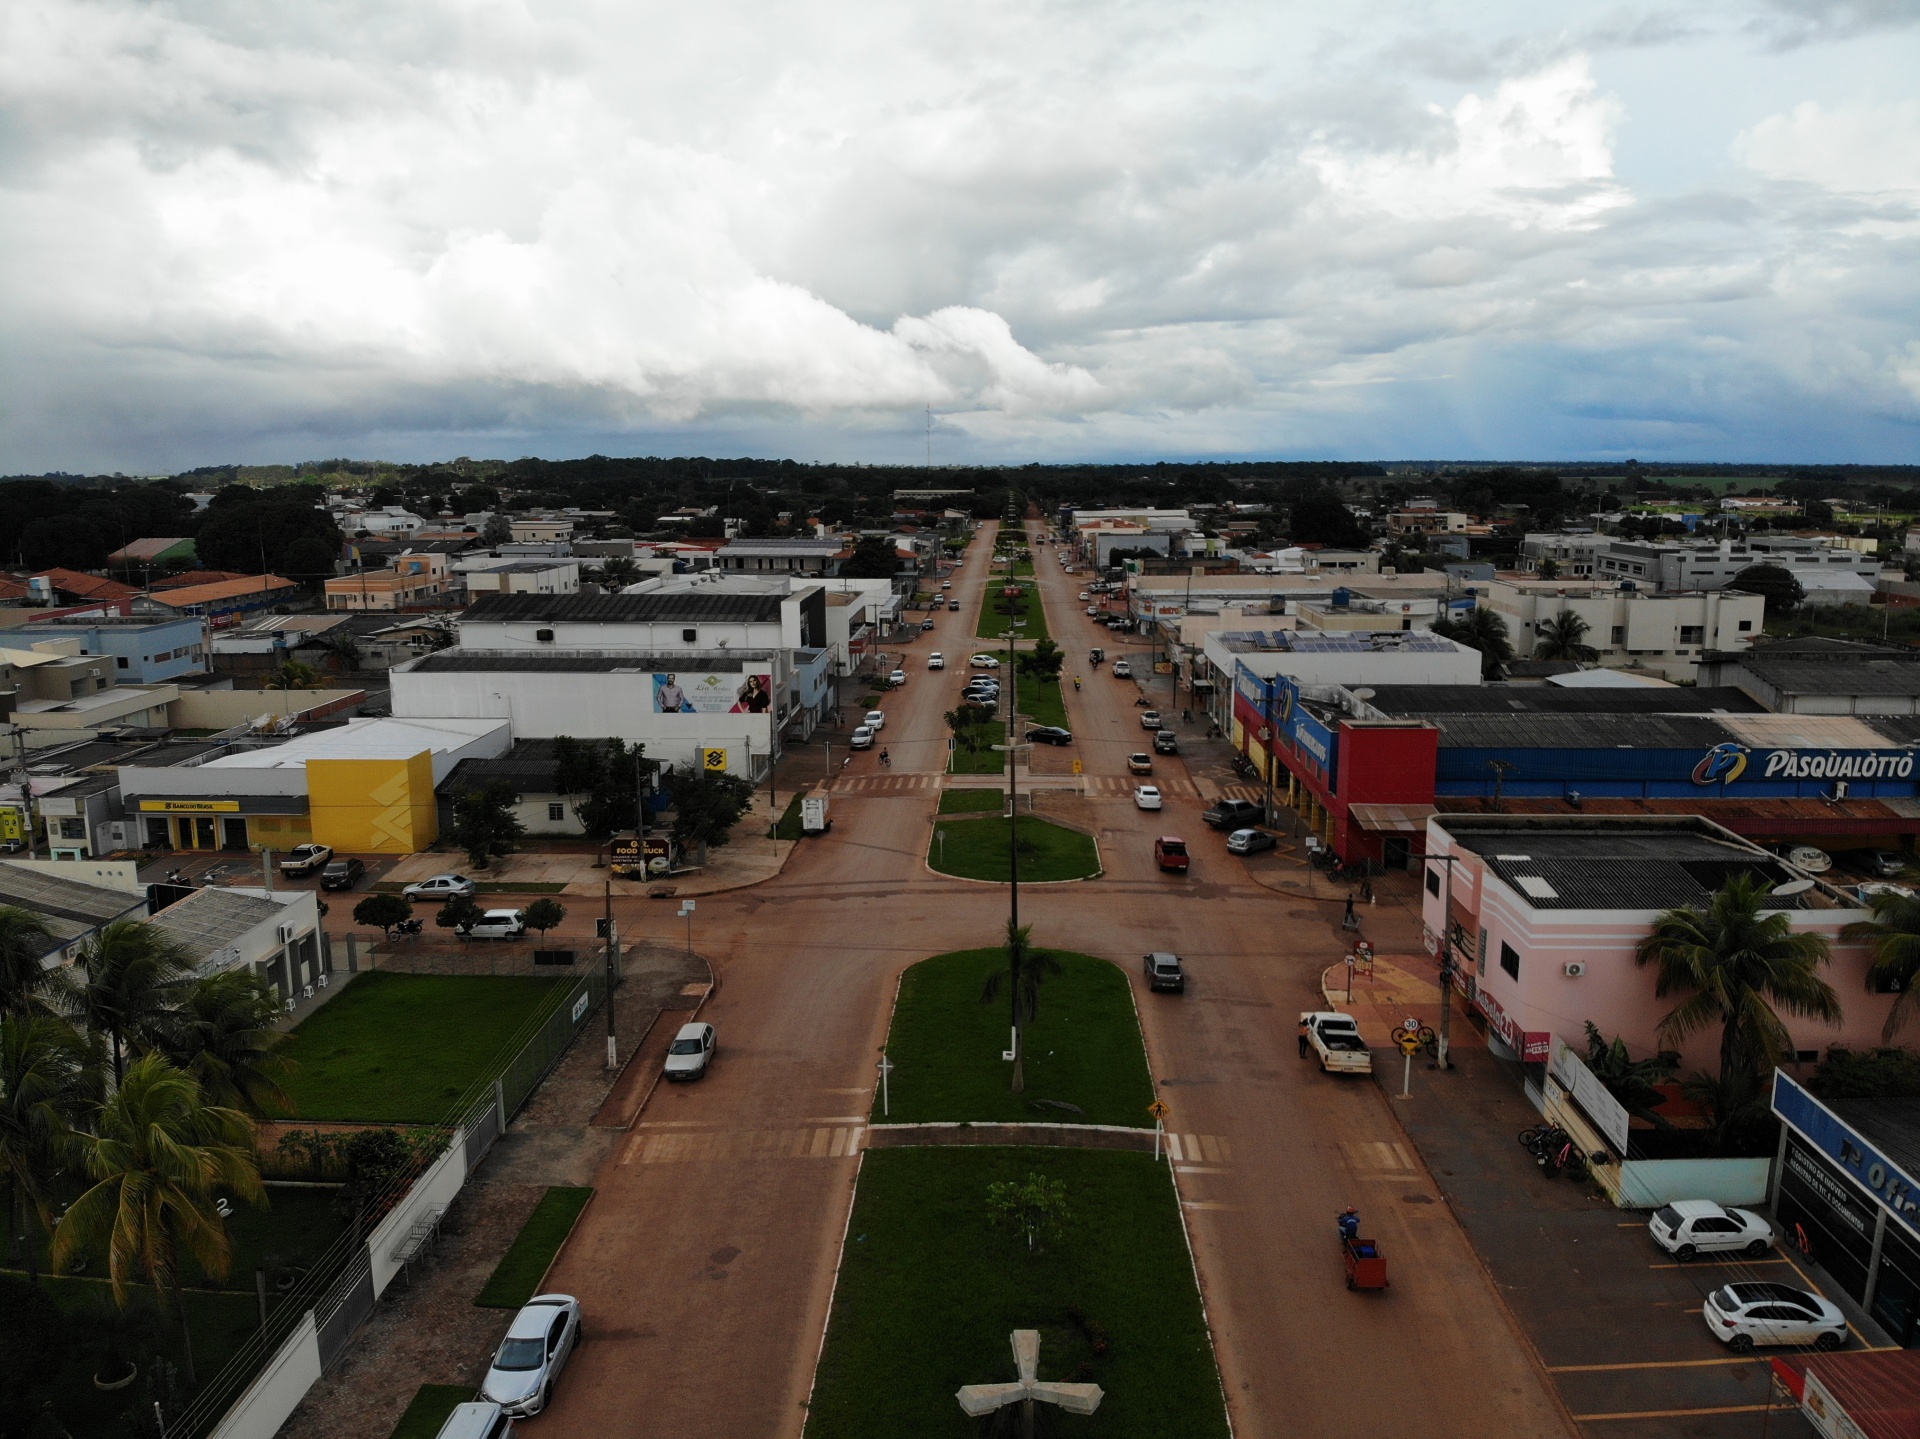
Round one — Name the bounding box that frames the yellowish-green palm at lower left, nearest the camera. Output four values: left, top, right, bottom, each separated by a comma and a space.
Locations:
54, 1055, 267, 1383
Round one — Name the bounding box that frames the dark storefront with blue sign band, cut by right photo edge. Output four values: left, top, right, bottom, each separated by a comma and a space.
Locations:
1774, 1072, 1920, 1349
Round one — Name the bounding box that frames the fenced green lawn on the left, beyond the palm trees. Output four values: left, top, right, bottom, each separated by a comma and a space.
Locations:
280, 970, 566, 1124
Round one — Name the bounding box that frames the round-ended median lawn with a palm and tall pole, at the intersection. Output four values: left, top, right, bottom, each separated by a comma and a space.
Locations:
874, 945, 1154, 1128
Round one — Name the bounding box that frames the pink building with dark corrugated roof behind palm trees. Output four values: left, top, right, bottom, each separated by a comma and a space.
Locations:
1421, 815, 1893, 1074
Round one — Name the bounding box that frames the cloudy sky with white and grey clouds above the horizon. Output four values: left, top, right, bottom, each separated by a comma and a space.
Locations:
0, 0, 1920, 473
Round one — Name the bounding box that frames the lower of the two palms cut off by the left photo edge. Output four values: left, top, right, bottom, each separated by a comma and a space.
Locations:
0, 1011, 92, 1283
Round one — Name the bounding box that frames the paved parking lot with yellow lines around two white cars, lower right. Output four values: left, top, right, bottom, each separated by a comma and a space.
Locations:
1377, 1047, 1887, 1439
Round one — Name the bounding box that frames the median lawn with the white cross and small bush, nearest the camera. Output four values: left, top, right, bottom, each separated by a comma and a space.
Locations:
806, 1147, 1227, 1439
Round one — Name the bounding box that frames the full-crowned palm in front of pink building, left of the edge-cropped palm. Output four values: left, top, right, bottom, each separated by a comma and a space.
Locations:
1634, 874, 1839, 1080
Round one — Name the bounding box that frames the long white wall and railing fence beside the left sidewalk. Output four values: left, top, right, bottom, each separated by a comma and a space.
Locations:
182, 964, 607, 1439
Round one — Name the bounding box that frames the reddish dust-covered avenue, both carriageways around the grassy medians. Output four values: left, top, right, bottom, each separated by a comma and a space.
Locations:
528, 526, 1571, 1439
